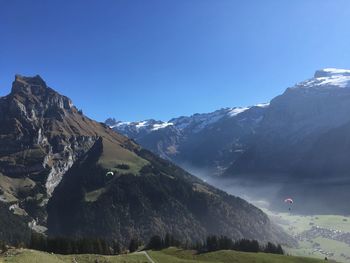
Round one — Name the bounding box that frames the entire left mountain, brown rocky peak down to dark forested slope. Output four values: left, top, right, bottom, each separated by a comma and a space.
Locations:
0, 76, 289, 245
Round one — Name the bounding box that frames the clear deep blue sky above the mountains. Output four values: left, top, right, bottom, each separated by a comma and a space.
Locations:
0, 0, 350, 121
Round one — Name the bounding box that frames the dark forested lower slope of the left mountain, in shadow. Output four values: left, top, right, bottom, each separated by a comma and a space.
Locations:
48, 141, 284, 246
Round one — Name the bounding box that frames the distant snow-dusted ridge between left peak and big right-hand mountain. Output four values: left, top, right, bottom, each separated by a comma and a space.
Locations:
106, 103, 269, 173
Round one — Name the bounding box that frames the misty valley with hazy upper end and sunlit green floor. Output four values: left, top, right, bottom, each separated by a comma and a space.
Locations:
187, 174, 350, 263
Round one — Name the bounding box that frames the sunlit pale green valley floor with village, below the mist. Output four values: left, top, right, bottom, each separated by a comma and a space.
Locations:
264, 212, 350, 262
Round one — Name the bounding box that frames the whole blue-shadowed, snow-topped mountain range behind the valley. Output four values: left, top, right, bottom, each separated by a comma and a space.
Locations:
106, 68, 350, 216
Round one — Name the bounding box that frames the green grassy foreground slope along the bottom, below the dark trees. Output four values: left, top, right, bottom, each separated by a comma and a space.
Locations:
0, 248, 323, 263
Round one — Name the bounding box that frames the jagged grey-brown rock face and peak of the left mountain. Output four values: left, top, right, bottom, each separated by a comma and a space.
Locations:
0, 76, 124, 224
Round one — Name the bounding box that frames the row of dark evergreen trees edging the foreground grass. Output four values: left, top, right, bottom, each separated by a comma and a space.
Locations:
22, 233, 284, 255
